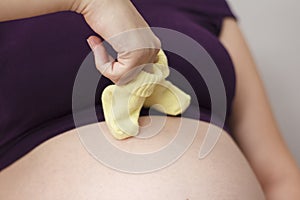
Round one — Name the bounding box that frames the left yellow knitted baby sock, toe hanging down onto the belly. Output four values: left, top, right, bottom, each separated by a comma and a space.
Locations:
102, 58, 166, 139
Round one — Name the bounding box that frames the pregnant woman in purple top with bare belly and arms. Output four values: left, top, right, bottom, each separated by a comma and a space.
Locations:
0, 0, 300, 200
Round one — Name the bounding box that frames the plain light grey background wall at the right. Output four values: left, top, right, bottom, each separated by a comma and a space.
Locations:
228, 0, 300, 165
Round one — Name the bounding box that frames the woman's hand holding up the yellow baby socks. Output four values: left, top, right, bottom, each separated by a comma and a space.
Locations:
72, 0, 160, 84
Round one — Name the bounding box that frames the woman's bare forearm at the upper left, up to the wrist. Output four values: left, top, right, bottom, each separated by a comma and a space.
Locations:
0, 0, 81, 21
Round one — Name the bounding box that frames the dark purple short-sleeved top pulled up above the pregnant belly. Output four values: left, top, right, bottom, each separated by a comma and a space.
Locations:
0, 0, 235, 170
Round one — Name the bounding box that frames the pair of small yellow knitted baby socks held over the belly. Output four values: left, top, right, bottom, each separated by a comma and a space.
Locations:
101, 50, 191, 139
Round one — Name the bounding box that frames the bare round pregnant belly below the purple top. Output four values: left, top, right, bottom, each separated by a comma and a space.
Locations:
0, 116, 264, 200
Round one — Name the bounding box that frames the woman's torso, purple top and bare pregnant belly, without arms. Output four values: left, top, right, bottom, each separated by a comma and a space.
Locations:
0, 0, 263, 200
